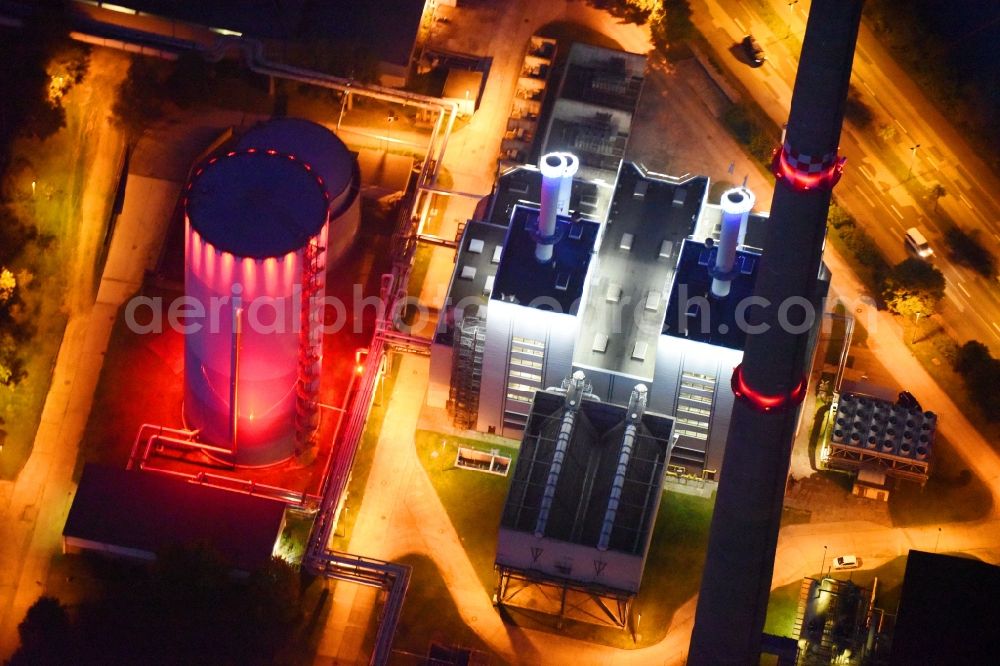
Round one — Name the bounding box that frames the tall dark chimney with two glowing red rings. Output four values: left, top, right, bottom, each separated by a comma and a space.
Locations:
688, 0, 862, 666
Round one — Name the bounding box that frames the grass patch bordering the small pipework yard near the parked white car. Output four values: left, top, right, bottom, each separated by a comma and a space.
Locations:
764, 556, 906, 638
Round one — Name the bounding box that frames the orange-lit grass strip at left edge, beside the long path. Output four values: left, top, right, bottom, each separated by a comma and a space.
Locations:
0, 49, 128, 479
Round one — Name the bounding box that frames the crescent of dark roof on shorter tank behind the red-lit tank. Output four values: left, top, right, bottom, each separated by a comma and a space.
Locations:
236, 118, 355, 199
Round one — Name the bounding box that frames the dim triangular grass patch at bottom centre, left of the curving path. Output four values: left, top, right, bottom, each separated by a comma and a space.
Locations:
393, 555, 506, 664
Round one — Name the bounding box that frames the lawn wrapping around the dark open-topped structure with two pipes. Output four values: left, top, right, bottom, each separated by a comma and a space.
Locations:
416, 431, 714, 649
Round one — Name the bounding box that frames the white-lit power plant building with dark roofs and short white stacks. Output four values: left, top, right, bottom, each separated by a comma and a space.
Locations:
432, 158, 804, 480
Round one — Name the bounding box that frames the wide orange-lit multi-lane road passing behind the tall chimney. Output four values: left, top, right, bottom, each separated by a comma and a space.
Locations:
691, 0, 1000, 355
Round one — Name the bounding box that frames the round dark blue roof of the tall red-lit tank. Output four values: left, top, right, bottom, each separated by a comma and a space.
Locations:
184, 148, 330, 259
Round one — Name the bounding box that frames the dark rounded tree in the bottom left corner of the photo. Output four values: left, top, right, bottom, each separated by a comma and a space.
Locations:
8, 596, 75, 666
